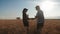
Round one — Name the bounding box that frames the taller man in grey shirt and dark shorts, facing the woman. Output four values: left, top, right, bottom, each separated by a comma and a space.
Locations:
35, 5, 44, 34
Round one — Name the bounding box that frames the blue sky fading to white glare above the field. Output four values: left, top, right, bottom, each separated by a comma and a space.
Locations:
0, 0, 60, 19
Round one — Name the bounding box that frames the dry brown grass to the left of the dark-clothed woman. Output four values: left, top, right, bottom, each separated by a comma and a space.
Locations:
0, 20, 25, 34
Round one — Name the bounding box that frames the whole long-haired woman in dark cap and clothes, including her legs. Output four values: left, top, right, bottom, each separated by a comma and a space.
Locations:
23, 8, 29, 34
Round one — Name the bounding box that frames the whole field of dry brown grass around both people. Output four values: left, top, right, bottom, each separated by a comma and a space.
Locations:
0, 19, 60, 34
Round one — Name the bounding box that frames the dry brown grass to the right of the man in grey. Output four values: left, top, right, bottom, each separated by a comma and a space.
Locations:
42, 20, 60, 34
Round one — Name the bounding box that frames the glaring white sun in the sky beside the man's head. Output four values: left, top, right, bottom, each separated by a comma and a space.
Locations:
39, 1, 54, 11
